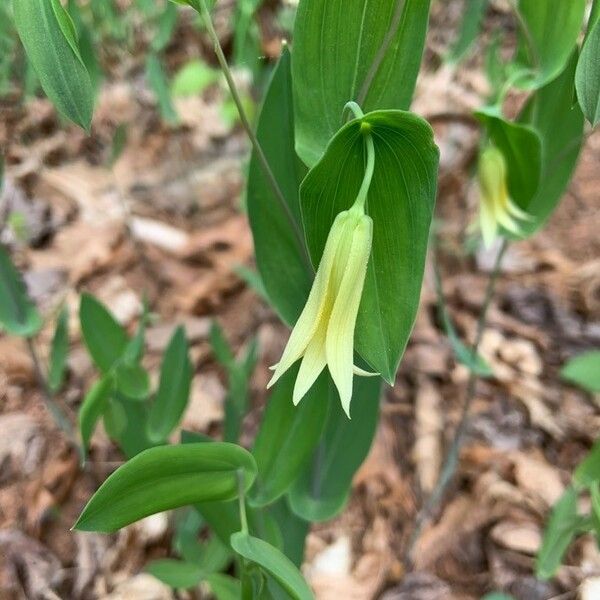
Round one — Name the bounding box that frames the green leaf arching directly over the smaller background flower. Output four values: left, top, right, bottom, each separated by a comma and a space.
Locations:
475, 109, 542, 210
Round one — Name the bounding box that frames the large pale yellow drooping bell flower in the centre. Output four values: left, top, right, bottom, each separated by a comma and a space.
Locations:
267, 203, 373, 418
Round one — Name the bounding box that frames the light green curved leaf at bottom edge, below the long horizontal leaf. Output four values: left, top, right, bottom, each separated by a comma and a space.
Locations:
231, 531, 314, 600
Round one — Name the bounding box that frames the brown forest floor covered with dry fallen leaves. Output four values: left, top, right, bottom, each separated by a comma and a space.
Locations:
0, 3, 600, 600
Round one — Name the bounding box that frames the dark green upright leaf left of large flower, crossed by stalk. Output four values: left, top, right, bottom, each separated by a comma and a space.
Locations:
246, 47, 313, 325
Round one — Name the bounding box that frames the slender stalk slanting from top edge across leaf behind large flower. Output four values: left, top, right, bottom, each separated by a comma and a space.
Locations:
197, 0, 314, 273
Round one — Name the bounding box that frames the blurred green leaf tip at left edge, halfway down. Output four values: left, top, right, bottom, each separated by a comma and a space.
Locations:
0, 246, 43, 337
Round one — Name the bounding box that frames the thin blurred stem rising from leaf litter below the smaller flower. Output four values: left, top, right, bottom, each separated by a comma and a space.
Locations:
405, 239, 508, 565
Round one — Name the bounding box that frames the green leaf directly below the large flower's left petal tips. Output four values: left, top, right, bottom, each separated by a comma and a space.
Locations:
250, 368, 329, 506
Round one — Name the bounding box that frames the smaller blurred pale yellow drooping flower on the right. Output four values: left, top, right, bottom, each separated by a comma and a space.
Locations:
477, 146, 531, 247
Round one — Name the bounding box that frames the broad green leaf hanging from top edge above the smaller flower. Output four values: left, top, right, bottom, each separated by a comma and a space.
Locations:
517, 0, 585, 89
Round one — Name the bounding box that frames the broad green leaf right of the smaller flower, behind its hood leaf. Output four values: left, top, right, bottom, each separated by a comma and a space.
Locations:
519, 53, 584, 233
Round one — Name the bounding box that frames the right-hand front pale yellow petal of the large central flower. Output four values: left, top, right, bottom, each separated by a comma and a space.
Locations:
325, 215, 373, 418
